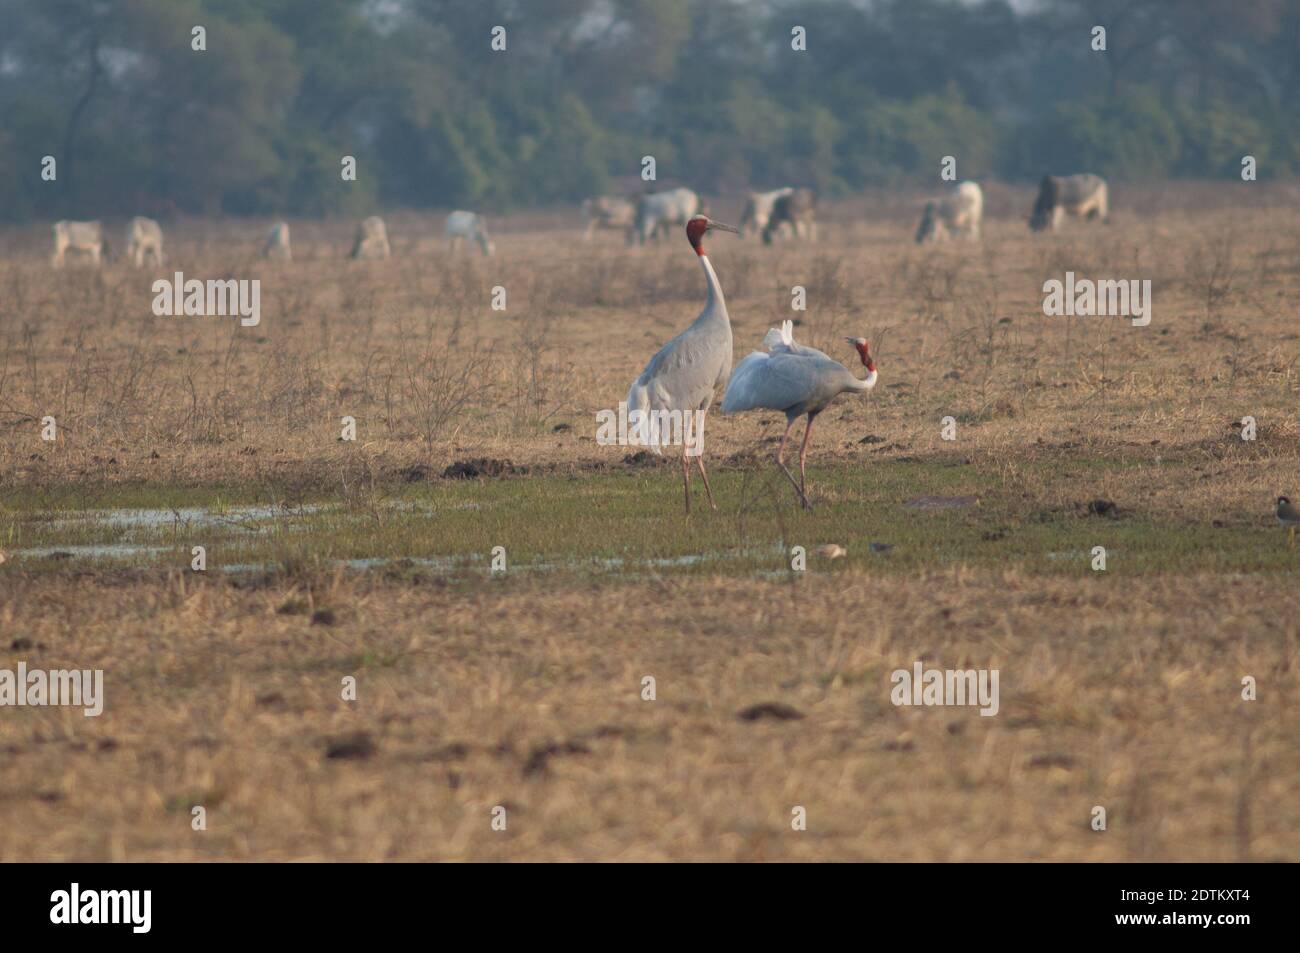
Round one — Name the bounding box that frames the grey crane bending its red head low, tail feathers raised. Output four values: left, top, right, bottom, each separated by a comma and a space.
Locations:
723, 321, 876, 510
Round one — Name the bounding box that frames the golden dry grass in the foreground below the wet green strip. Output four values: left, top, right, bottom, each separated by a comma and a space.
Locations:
0, 569, 1300, 861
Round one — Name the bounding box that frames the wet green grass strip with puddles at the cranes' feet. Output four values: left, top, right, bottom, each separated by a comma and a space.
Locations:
0, 459, 1300, 577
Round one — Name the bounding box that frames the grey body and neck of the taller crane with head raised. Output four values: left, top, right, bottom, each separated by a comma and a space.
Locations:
628, 255, 732, 454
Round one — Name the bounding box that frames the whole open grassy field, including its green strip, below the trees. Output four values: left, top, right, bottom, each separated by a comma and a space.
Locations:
0, 183, 1300, 861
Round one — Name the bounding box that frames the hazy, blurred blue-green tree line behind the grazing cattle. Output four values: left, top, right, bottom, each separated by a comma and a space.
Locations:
0, 0, 1300, 218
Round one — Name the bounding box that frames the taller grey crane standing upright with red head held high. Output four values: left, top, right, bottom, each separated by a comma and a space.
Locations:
628, 215, 740, 516
